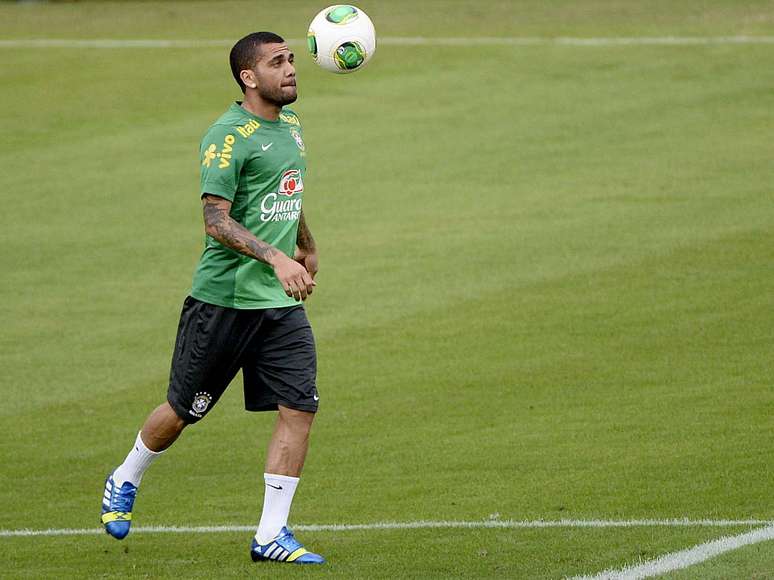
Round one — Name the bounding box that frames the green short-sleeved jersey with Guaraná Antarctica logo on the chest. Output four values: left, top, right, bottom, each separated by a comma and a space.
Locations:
191, 103, 306, 309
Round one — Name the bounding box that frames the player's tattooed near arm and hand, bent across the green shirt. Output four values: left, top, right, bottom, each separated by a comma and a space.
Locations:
202, 193, 314, 300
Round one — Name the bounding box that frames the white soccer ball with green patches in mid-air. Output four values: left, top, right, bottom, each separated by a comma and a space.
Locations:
306, 4, 376, 74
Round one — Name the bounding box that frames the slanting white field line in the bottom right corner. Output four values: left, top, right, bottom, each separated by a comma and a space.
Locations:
573, 526, 774, 580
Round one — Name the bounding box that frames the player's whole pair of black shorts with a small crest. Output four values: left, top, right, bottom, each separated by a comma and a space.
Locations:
167, 296, 319, 423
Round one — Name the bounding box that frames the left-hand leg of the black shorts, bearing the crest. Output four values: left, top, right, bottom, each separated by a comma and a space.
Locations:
167, 296, 255, 423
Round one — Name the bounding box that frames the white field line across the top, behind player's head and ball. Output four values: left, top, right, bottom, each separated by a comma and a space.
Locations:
0, 36, 774, 48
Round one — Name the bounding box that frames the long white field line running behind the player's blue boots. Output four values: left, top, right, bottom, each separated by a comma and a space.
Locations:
0, 519, 774, 538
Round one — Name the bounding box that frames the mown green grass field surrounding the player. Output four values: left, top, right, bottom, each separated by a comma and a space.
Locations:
0, 0, 774, 580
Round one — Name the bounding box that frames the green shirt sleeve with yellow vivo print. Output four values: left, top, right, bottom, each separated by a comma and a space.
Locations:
200, 125, 247, 201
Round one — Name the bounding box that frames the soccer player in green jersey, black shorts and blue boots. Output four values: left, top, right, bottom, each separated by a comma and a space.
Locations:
101, 32, 325, 564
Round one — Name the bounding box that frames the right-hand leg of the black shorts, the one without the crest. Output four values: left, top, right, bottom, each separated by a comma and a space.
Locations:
242, 306, 320, 412
